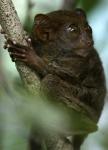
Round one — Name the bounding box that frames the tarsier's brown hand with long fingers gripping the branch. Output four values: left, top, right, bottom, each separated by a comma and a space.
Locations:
4, 39, 44, 69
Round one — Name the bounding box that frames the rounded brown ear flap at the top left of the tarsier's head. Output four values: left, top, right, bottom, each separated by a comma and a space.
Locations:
34, 14, 49, 24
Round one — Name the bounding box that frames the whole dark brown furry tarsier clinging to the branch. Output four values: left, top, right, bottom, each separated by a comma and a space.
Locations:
4, 9, 106, 150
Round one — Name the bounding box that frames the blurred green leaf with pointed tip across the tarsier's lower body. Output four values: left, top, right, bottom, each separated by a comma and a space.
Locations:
23, 98, 98, 136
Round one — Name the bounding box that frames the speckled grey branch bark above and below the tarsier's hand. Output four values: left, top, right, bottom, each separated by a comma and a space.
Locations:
0, 0, 40, 94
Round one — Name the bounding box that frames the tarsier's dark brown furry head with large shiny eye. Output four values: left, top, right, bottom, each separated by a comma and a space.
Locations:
32, 9, 93, 49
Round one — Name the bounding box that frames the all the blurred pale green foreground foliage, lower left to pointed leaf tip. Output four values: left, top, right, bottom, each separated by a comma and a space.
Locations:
0, 78, 97, 150
